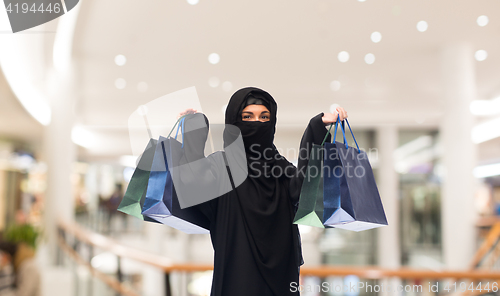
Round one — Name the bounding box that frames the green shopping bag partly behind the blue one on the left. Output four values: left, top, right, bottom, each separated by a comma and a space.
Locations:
117, 139, 157, 222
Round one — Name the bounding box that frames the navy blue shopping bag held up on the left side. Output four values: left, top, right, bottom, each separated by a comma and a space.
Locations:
142, 117, 210, 234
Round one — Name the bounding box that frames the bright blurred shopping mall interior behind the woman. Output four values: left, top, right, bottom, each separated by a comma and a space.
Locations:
0, 0, 500, 296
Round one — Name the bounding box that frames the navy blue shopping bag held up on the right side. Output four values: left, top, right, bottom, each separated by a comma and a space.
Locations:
323, 118, 387, 231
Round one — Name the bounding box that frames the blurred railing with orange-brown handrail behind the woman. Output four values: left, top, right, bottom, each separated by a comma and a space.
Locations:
58, 221, 500, 296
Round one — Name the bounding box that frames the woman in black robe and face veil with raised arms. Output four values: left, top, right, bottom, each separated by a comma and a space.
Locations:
181, 87, 347, 296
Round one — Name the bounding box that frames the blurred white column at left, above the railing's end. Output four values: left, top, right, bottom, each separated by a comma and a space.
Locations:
43, 71, 76, 264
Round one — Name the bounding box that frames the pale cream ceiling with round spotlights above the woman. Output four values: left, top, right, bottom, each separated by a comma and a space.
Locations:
2, 0, 500, 162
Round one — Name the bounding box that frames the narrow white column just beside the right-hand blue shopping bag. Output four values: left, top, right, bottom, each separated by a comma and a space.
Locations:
377, 125, 401, 295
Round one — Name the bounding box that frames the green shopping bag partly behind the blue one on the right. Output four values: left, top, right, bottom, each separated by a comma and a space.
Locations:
293, 142, 326, 228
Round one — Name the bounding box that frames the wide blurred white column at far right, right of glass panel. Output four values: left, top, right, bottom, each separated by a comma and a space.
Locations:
440, 45, 476, 269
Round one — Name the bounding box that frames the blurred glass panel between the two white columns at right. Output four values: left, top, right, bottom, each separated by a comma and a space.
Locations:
395, 131, 442, 268
